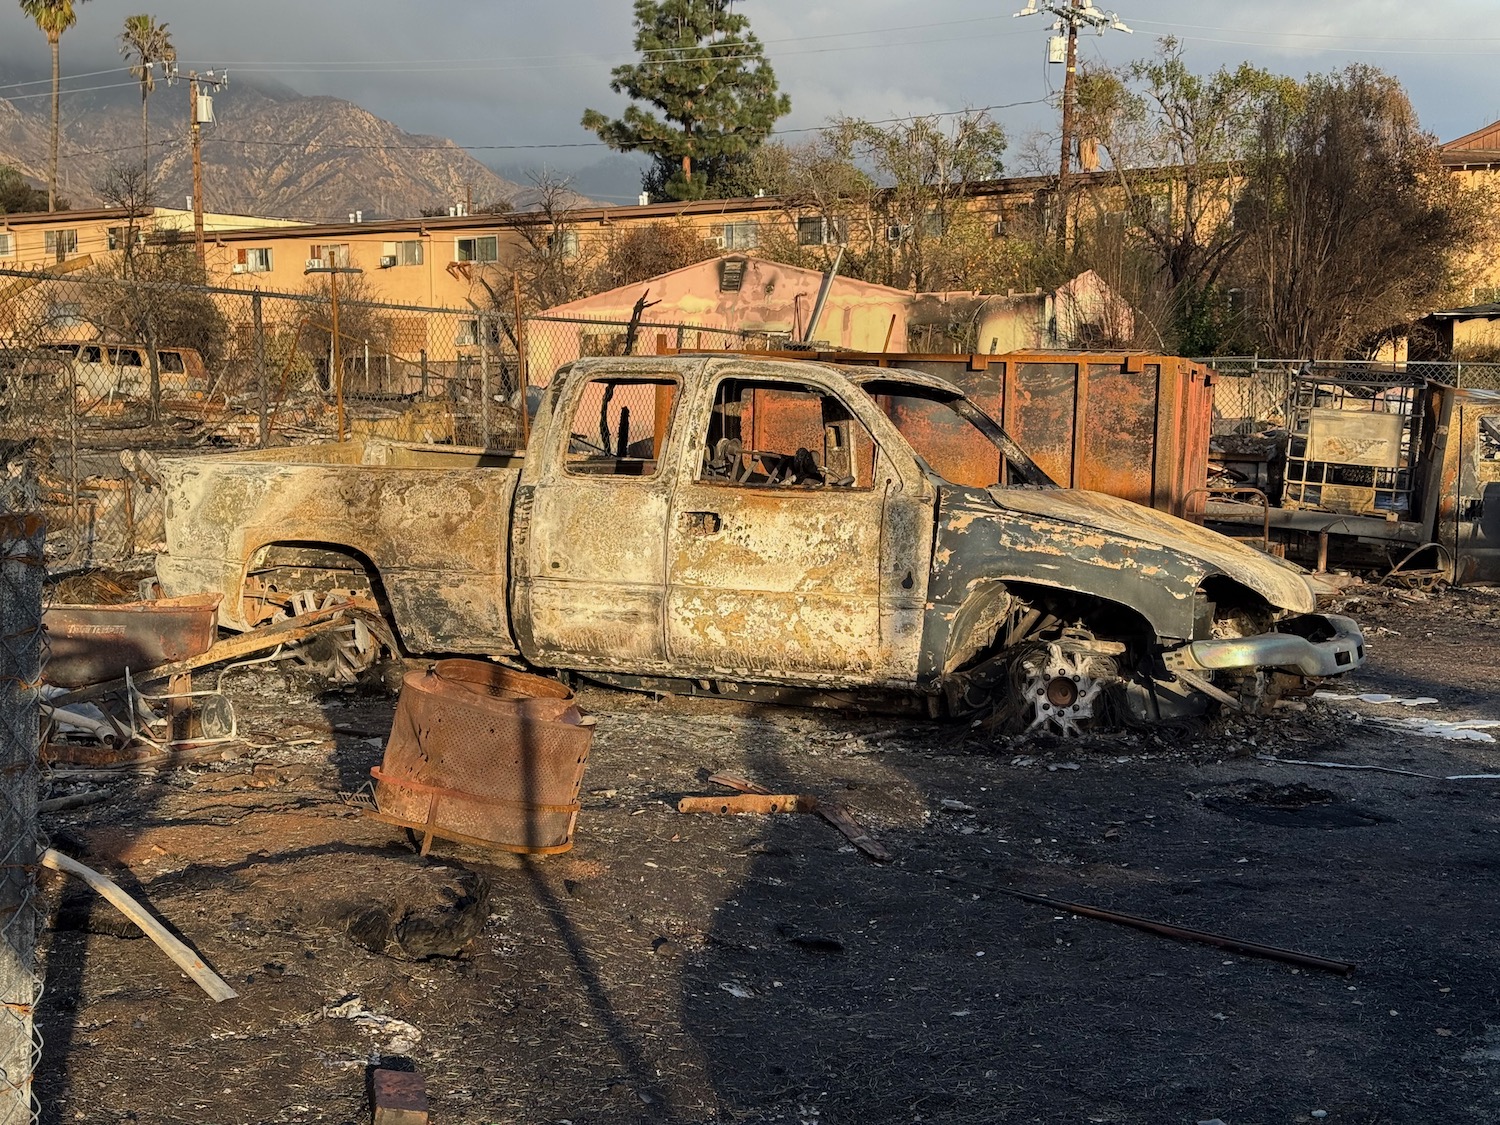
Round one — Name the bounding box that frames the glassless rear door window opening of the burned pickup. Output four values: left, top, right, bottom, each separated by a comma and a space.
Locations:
564, 377, 678, 477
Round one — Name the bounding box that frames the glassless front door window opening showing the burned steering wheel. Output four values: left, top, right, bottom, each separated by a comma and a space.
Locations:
699, 378, 875, 489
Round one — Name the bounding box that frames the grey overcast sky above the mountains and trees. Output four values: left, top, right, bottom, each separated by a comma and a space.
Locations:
0, 0, 1500, 201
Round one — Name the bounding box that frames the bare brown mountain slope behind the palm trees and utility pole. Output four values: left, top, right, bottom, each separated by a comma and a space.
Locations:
0, 73, 527, 221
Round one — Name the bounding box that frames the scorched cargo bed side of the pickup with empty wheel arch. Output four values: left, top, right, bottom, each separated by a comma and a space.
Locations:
158, 440, 521, 656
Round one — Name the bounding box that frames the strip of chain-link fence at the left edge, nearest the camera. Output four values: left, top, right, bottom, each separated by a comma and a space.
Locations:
0, 453, 45, 1125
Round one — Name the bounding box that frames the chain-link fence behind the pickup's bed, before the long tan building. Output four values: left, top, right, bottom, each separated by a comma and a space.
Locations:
0, 269, 750, 569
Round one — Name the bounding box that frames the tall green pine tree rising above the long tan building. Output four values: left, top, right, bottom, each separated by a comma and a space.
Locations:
584, 0, 792, 200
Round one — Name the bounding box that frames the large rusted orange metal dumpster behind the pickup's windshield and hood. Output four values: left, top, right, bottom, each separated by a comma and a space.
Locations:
675, 351, 1214, 518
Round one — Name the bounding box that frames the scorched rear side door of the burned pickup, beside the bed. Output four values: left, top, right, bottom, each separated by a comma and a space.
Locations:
516, 368, 681, 674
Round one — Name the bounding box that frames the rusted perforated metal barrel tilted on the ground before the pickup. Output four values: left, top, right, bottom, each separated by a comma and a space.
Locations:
371, 660, 594, 855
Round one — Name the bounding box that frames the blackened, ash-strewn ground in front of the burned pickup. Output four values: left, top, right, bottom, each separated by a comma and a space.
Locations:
26, 591, 1500, 1125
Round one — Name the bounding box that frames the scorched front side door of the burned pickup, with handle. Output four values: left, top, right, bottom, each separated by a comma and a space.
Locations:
666, 374, 932, 686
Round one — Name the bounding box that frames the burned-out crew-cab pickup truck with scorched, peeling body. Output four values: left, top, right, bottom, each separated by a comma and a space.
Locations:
158, 354, 1365, 732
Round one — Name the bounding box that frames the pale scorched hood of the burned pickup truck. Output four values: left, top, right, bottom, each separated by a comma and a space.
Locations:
989, 489, 1317, 614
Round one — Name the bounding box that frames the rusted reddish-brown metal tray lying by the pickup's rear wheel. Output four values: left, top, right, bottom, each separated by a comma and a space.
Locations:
42, 594, 222, 687
